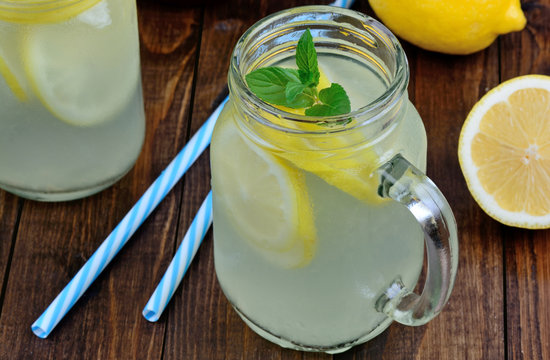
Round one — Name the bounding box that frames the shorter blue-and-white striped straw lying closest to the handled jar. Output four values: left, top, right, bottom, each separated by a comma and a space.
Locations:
143, 191, 212, 322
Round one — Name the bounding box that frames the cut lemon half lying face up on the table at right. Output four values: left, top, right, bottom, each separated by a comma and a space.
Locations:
458, 75, 550, 229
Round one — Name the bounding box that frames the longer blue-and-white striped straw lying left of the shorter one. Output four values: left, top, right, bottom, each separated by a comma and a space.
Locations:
31, 98, 227, 338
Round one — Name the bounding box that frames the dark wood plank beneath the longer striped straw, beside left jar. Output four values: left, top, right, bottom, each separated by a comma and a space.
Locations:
0, 2, 201, 359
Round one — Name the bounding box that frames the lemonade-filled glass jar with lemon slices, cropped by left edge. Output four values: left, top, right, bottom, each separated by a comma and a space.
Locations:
0, 0, 145, 201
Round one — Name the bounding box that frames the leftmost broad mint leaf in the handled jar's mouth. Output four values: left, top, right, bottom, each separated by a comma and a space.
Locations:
246, 66, 302, 107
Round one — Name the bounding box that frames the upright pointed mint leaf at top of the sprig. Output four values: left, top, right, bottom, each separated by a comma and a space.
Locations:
296, 29, 320, 86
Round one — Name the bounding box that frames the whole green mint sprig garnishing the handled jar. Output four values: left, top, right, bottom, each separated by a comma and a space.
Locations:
246, 29, 351, 116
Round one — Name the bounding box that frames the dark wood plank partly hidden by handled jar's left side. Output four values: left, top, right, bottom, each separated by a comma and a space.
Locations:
164, 0, 331, 360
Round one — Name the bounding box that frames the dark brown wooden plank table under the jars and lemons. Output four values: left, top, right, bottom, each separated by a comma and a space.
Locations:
0, 0, 550, 360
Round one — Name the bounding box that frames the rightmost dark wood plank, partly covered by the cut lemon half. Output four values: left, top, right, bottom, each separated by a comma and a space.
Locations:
501, 0, 550, 360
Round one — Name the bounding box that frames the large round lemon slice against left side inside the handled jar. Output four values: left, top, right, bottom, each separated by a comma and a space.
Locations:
211, 110, 316, 268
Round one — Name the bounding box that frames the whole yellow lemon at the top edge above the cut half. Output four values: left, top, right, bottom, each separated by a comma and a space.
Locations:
369, 0, 526, 55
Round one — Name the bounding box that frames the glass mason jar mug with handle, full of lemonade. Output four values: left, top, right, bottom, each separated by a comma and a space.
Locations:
211, 6, 458, 353
